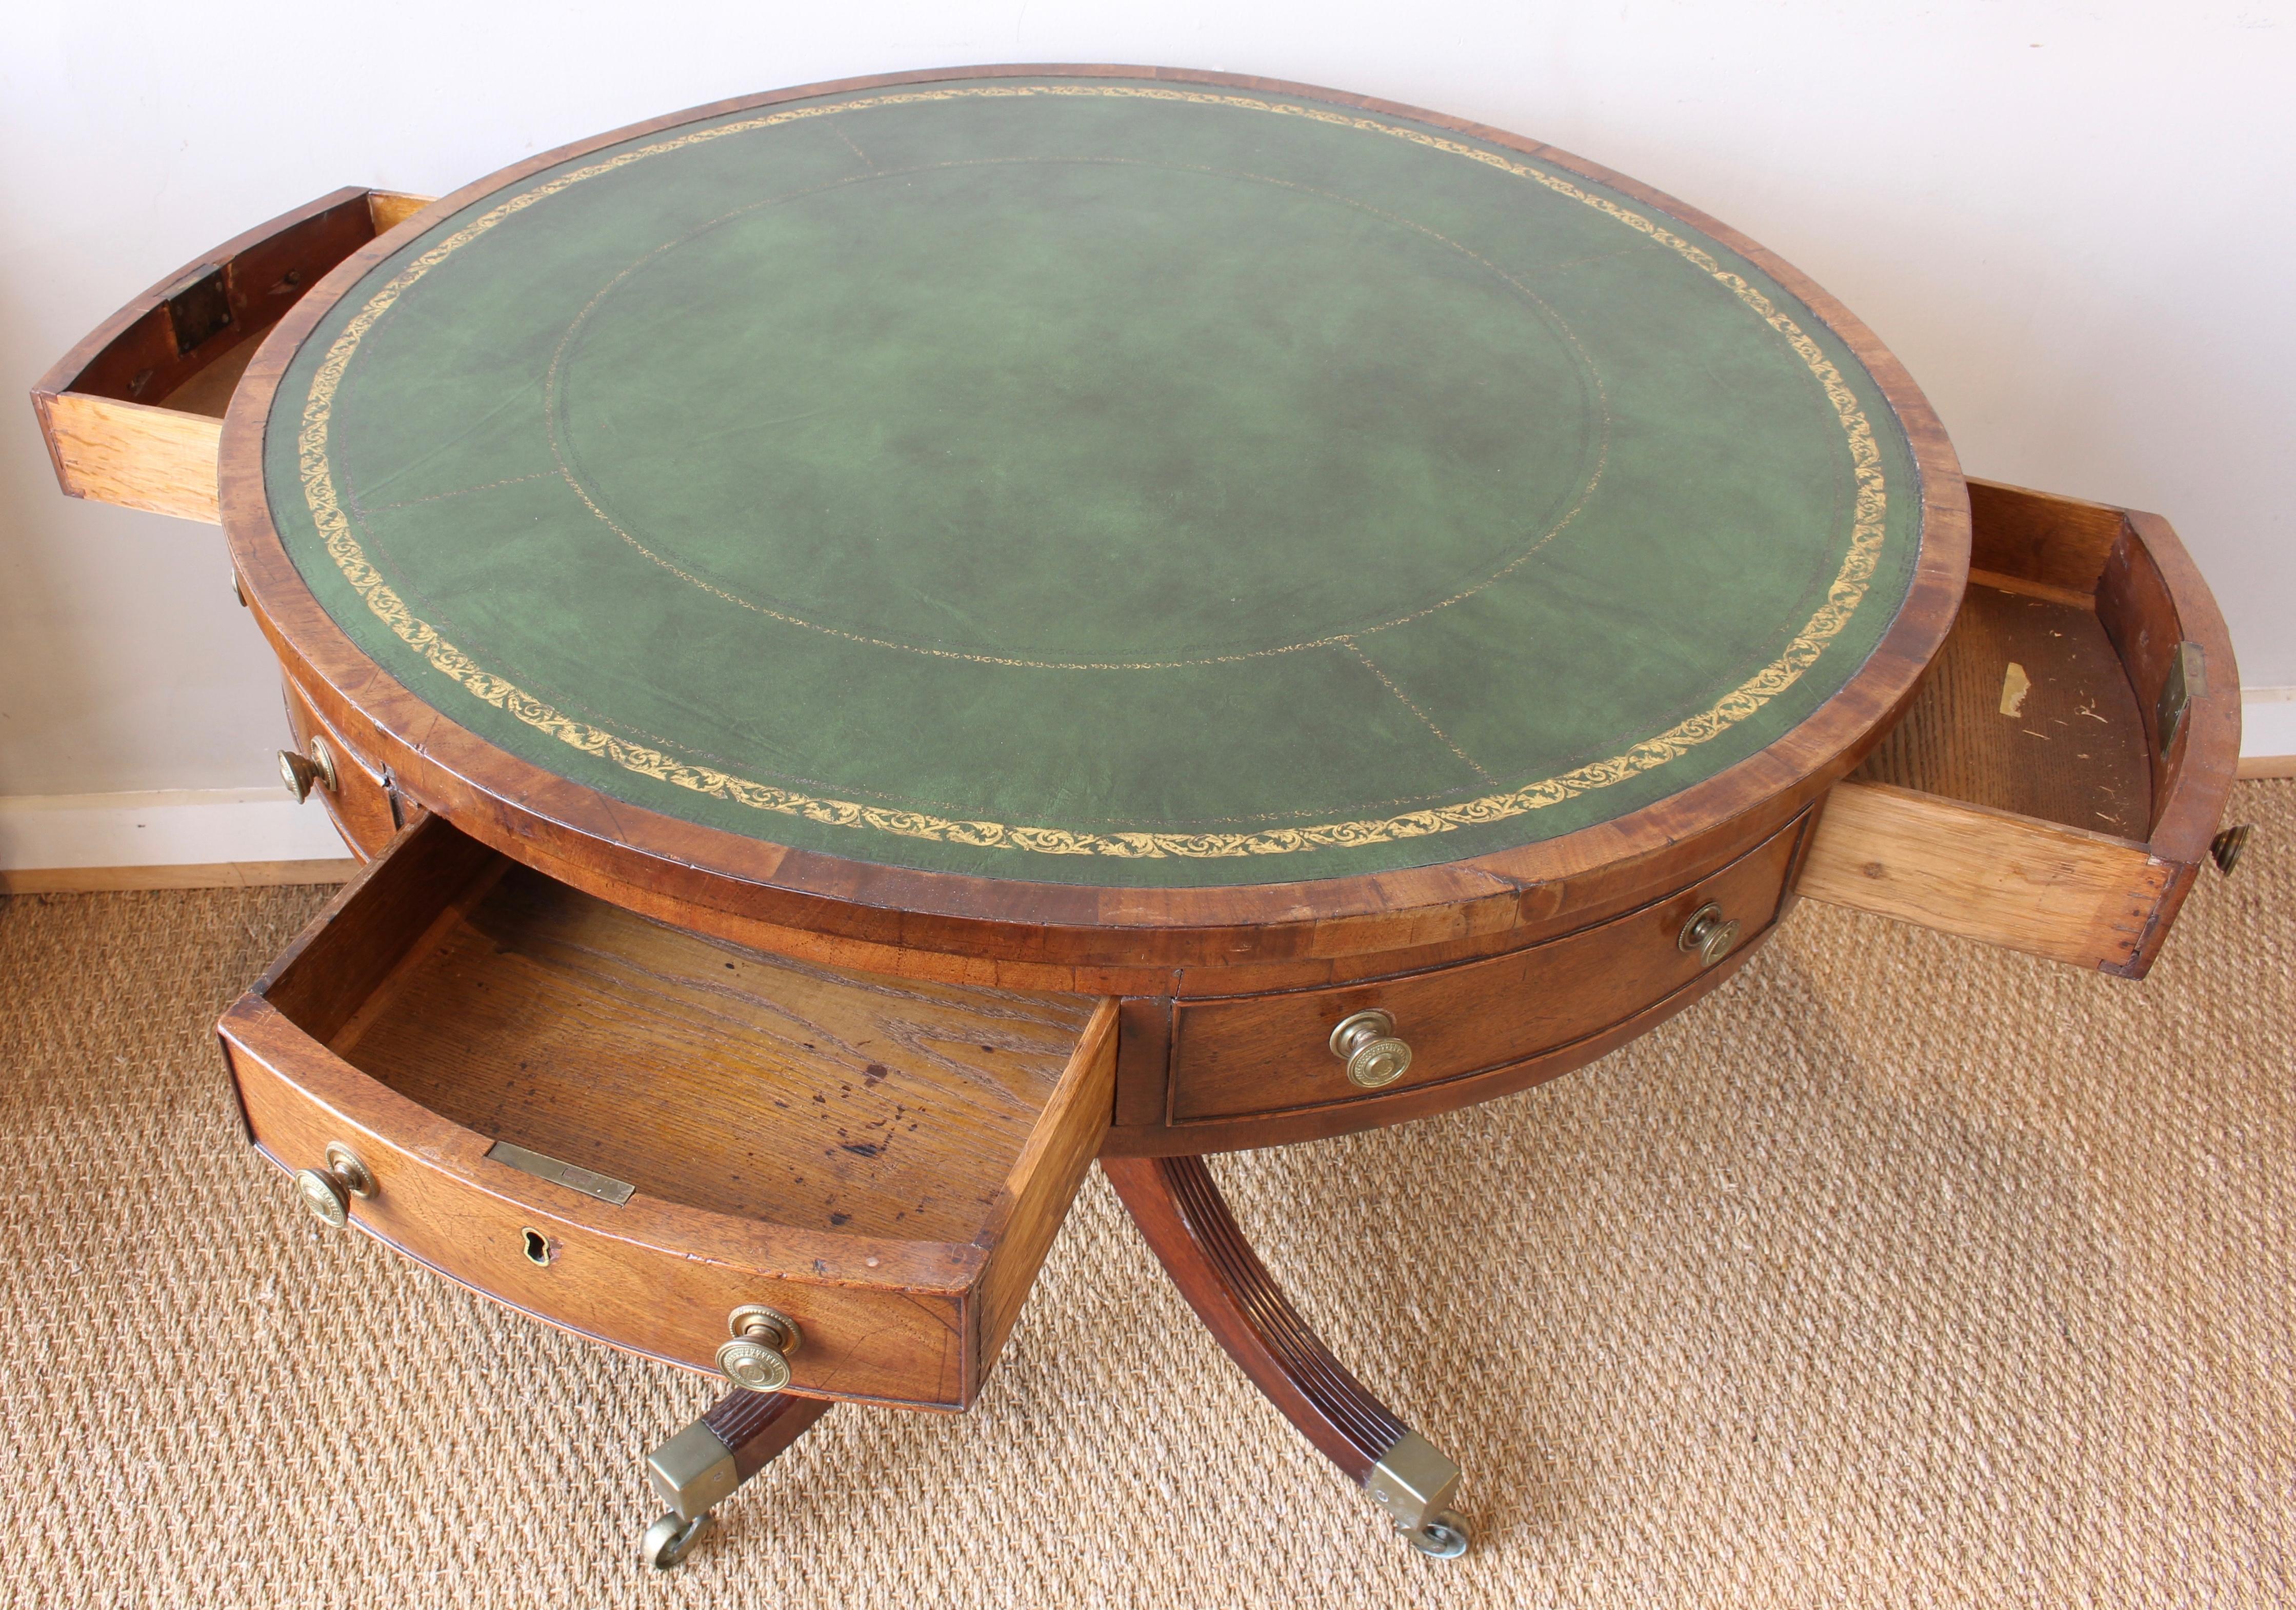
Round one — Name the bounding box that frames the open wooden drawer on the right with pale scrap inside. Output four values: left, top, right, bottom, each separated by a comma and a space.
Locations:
1800, 480, 2241, 979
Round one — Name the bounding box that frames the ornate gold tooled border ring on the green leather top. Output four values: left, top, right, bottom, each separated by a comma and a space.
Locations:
296, 85, 1890, 859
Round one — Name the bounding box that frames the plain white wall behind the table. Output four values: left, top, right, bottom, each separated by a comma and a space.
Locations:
0, 0, 2296, 797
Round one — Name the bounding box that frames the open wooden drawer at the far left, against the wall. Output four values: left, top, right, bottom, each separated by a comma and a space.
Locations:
32, 188, 429, 524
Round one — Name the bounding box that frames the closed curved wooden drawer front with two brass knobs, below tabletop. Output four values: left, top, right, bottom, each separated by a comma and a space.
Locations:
1171, 816, 1809, 1123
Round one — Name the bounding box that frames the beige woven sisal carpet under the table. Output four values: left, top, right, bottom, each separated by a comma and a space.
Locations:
0, 783, 2296, 1610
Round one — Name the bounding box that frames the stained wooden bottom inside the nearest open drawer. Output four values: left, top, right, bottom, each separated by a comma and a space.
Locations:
344, 866, 1104, 1243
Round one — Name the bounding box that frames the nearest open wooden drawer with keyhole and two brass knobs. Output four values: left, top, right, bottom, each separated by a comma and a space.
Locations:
221, 818, 1116, 1408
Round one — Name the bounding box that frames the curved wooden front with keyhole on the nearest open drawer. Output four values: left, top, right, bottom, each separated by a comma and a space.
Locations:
225, 1022, 967, 1408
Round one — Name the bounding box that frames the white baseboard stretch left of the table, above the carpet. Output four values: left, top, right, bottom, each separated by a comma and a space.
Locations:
0, 788, 351, 893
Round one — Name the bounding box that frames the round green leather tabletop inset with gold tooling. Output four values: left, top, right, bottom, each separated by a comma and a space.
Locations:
264, 81, 1922, 886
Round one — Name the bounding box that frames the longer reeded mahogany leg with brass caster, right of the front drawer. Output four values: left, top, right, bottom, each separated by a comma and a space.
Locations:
1100, 1158, 1472, 1559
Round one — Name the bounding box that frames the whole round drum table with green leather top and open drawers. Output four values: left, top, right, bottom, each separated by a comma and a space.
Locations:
34, 67, 2239, 1566
